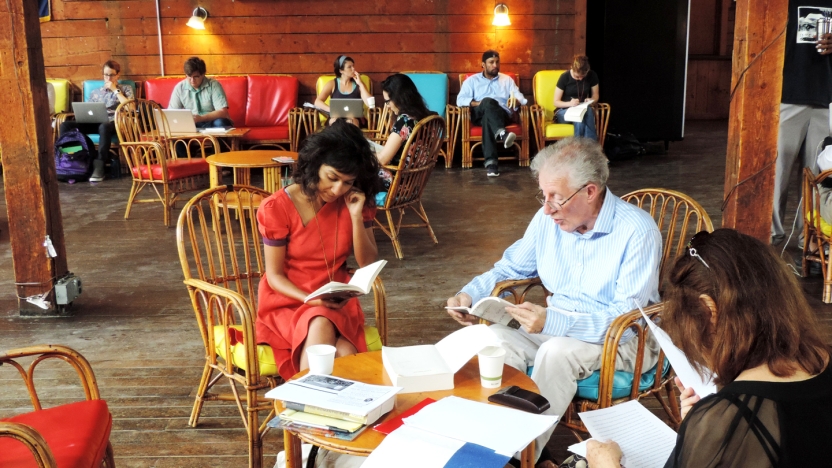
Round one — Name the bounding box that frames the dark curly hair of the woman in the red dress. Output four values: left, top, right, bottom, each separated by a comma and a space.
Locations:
293, 119, 381, 206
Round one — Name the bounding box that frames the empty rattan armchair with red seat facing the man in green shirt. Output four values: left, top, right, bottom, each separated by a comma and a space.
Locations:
115, 99, 220, 226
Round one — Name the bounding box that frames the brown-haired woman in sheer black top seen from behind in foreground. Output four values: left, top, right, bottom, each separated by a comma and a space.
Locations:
587, 229, 832, 468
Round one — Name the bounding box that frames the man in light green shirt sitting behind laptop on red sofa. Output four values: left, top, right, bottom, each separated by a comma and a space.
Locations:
168, 57, 234, 128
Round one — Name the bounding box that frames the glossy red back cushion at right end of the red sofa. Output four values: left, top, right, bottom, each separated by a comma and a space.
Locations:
245, 75, 298, 129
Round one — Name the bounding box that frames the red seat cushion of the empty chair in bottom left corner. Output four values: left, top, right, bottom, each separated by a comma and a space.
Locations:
0, 400, 113, 468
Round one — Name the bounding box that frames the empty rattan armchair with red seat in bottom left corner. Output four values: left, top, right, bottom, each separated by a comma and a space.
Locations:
0, 345, 115, 468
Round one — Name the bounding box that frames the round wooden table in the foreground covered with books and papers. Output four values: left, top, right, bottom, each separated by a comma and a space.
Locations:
275, 351, 538, 468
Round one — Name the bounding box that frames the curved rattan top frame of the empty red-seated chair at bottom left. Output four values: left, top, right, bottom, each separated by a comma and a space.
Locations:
0, 345, 100, 411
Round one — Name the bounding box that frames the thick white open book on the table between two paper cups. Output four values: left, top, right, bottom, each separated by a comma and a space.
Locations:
381, 325, 501, 393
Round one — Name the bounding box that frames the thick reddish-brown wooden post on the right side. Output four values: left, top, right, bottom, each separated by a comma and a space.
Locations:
722, 0, 794, 238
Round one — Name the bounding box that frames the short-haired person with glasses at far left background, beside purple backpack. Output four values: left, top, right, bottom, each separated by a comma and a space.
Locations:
58, 60, 133, 182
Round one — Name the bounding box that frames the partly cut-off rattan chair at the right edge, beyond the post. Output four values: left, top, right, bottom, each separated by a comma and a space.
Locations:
803, 168, 832, 304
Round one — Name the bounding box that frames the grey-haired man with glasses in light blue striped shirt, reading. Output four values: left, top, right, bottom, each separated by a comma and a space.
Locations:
448, 138, 662, 467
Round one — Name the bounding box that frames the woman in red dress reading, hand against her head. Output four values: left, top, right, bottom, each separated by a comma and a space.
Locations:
256, 121, 379, 379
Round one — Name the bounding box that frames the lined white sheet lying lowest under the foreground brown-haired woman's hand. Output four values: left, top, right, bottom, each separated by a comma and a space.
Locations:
580, 400, 676, 468
